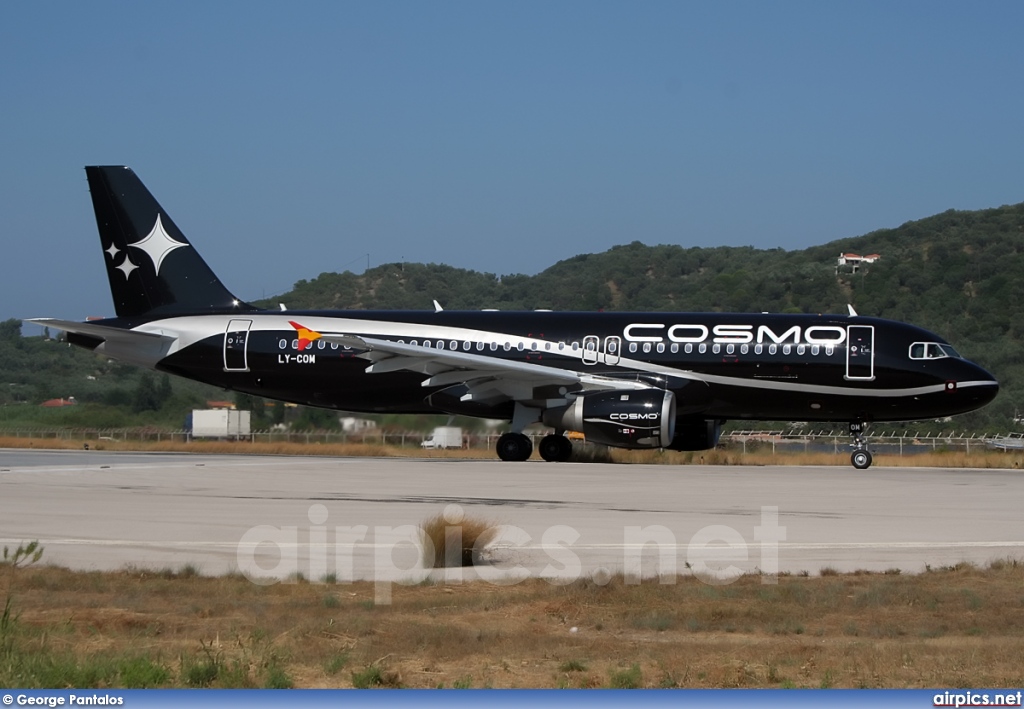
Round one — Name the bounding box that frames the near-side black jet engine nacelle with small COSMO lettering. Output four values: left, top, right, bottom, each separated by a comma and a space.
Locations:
542, 389, 676, 448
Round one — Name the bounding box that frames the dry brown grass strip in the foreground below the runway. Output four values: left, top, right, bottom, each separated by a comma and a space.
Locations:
0, 560, 1024, 687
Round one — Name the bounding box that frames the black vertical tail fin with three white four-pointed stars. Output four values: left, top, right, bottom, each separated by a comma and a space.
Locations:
85, 166, 253, 318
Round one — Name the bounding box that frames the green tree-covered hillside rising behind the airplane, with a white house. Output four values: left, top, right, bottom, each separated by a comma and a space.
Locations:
264, 204, 1024, 429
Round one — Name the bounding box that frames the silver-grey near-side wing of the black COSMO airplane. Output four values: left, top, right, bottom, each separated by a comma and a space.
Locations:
321, 333, 653, 406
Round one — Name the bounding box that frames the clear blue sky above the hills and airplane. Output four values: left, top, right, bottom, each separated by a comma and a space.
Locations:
0, 0, 1024, 323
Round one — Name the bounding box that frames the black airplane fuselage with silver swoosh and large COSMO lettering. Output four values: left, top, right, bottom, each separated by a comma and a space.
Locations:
126, 310, 997, 421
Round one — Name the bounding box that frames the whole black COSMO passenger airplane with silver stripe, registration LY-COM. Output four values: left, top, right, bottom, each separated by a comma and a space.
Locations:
29, 166, 998, 469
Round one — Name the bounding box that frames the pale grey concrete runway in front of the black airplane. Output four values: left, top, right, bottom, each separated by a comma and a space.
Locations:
0, 450, 1024, 582
